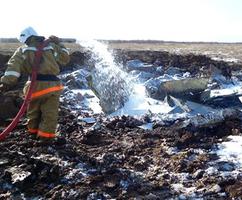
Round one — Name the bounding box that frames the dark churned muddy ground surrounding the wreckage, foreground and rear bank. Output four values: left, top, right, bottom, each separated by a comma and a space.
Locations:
0, 41, 242, 200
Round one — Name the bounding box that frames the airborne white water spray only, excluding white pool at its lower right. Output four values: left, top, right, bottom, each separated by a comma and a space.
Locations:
79, 40, 134, 113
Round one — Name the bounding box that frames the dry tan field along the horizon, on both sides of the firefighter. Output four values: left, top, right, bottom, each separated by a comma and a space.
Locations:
0, 41, 242, 63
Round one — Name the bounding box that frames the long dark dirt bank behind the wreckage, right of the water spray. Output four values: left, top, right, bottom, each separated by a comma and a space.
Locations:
116, 50, 242, 76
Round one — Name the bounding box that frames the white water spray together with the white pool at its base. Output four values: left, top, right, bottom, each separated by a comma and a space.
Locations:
76, 41, 171, 116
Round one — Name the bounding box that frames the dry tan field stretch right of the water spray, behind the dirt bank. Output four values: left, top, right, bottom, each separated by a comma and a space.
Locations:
109, 41, 242, 62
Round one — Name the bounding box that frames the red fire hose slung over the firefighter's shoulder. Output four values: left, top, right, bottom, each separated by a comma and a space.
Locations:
0, 40, 49, 141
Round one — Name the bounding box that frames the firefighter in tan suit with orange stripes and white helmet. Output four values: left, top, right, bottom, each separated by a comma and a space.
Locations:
0, 27, 70, 141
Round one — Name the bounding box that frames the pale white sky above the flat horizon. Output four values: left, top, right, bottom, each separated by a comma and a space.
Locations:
0, 0, 242, 42
